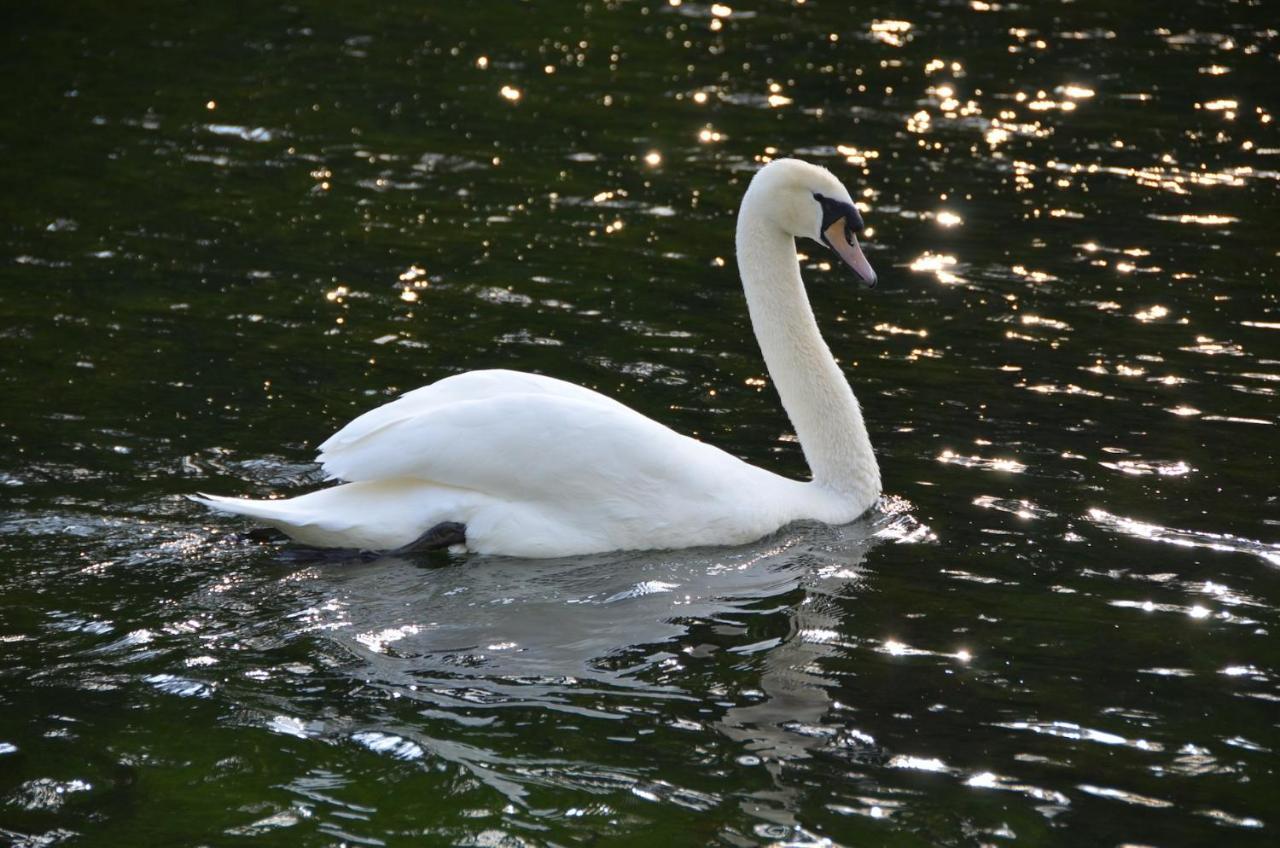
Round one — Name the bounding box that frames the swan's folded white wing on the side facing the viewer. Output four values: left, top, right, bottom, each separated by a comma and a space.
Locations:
320, 378, 755, 512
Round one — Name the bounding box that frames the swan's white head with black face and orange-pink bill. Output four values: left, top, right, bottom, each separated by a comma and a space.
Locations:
744, 159, 876, 287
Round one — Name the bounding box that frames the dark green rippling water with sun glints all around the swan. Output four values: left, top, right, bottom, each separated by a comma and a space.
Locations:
0, 0, 1280, 847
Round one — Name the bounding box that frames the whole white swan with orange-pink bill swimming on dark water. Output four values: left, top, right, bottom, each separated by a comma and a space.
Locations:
191, 159, 881, 557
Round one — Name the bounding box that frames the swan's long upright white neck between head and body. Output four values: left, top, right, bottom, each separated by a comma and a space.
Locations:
737, 191, 879, 498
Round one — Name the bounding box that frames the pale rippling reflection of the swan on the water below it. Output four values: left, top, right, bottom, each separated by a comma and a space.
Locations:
247, 514, 911, 828
